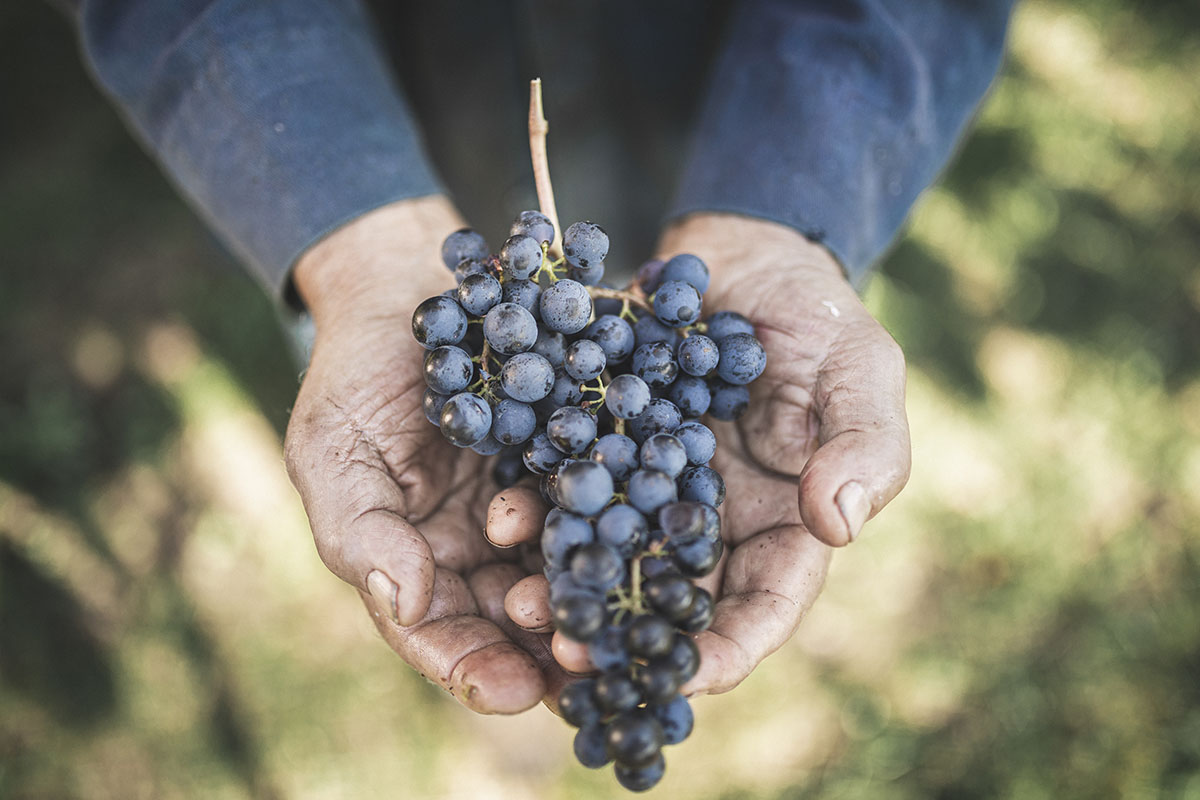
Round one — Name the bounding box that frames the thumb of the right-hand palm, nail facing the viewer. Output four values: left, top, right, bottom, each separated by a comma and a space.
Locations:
799, 327, 912, 547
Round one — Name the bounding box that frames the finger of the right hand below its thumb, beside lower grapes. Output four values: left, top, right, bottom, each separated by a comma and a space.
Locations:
680, 525, 829, 694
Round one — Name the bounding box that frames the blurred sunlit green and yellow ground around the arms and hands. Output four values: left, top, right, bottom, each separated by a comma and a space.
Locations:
0, 0, 1200, 800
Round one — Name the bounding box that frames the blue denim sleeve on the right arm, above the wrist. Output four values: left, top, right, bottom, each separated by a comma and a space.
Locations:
670, 0, 1013, 283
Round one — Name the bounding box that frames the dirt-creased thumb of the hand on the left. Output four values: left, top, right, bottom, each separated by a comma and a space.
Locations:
286, 413, 434, 625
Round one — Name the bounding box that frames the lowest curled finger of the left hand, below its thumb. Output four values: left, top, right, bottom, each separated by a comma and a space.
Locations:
364, 570, 546, 714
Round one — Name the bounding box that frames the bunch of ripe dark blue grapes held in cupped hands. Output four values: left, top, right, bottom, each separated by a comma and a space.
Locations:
413, 211, 767, 790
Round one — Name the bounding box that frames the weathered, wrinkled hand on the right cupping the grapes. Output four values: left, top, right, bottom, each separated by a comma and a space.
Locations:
510, 213, 910, 694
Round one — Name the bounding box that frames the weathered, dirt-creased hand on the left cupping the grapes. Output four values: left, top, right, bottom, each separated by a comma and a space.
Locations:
286, 198, 560, 712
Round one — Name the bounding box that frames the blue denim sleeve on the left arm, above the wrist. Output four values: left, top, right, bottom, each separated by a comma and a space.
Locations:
77, 0, 440, 296
